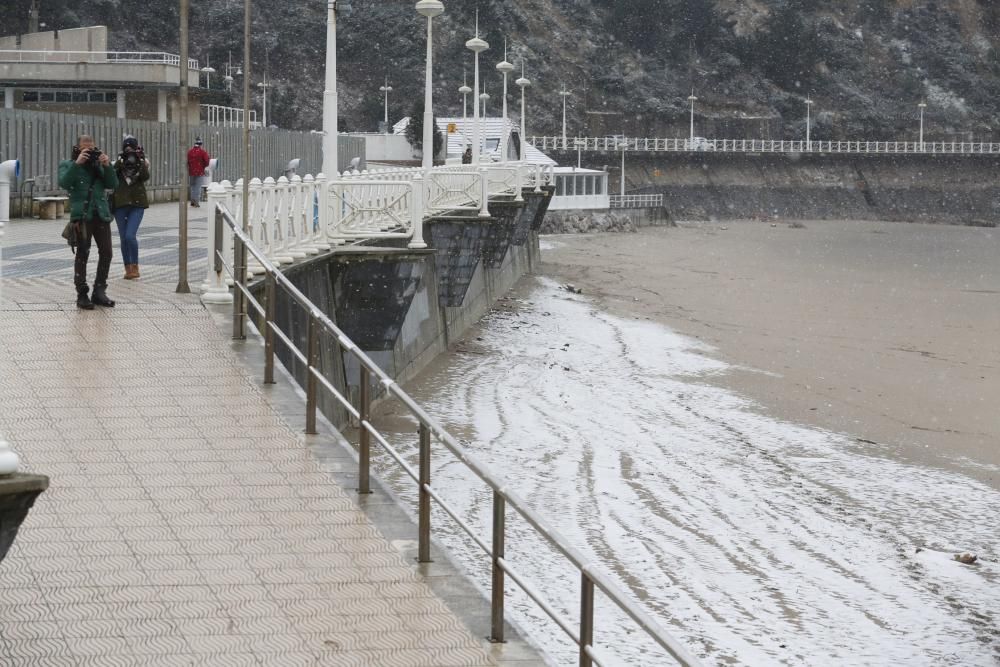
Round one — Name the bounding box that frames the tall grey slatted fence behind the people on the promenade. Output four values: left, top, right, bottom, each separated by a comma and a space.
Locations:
0, 109, 365, 194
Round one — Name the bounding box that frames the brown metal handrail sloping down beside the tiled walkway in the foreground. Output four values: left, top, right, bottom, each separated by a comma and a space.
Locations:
214, 203, 701, 667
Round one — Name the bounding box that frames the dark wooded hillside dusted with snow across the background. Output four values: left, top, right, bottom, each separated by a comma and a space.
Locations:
0, 0, 1000, 140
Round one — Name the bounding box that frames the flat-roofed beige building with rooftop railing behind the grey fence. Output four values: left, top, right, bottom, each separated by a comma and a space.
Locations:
0, 26, 200, 123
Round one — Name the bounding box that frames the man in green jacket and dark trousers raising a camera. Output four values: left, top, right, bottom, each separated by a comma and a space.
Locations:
59, 134, 118, 310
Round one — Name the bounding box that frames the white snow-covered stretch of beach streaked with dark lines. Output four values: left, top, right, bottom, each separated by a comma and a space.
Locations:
376, 280, 1000, 665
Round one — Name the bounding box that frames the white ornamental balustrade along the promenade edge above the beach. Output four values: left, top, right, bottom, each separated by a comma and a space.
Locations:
202, 162, 555, 300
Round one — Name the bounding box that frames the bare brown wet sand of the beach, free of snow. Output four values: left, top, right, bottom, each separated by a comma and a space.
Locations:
542, 222, 1000, 489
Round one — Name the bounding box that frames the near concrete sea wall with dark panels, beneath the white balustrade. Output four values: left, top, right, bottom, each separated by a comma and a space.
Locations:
250, 191, 551, 426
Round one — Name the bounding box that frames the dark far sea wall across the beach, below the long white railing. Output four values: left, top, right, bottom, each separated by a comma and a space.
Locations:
552, 152, 1000, 226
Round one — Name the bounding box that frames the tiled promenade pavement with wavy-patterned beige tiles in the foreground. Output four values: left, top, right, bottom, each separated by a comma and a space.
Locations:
0, 205, 492, 667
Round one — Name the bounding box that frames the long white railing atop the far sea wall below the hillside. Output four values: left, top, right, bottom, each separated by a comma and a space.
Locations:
528, 137, 1000, 155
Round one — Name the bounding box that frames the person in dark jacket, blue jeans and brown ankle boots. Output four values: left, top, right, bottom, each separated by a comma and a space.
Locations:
113, 136, 149, 280
